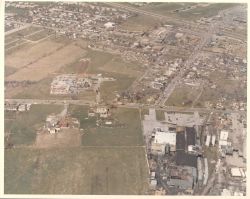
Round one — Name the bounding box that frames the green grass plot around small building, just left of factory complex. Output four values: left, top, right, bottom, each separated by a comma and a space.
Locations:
69, 105, 143, 146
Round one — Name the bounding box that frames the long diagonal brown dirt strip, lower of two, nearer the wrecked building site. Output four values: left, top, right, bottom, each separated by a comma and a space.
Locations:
6, 44, 85, 81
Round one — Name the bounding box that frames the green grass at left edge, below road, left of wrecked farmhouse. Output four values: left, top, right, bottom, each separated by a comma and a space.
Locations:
4, 105, 62, 145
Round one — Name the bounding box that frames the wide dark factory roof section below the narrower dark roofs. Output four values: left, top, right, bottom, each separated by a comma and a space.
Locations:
175, 151, 197, 168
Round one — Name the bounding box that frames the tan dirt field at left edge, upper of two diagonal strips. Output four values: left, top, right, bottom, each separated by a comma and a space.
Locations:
5, 41, 62, 68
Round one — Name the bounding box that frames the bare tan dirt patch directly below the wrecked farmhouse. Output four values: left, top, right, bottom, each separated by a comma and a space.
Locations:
35, 129, 81, 148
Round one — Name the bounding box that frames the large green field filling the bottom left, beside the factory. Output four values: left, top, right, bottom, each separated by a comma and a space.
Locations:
4, 147, 148, 195
